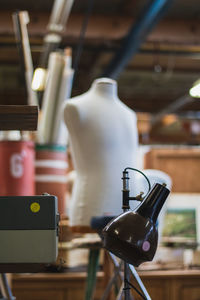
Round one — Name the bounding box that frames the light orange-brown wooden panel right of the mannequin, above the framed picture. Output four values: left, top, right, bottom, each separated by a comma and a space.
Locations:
144, 146, 200, 193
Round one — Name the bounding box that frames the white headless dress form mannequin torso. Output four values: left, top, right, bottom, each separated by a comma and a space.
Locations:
64, 78, 138, 227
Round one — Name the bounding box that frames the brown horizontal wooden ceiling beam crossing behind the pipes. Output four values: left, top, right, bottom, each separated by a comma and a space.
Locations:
0, 11, 200, 45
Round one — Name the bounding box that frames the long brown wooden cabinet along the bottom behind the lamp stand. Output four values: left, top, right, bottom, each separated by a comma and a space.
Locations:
12, 270, 200, 300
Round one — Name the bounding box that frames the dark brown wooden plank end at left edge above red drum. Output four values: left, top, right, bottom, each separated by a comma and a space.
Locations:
0, 105, 38, 131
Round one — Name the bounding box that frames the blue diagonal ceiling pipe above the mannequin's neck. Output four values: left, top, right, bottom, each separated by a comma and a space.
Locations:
102, 0, 173, 79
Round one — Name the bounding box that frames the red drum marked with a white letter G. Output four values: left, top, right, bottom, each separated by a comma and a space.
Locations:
0, 141, 35, 196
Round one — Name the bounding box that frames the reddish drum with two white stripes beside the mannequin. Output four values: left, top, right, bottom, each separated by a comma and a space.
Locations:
35, 145, 68, 215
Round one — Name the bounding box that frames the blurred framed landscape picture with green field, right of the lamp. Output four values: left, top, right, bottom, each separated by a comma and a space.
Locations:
162, 193, 200, 247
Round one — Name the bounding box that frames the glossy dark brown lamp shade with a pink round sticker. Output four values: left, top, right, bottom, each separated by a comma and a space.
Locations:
102, 183, 169, 267
